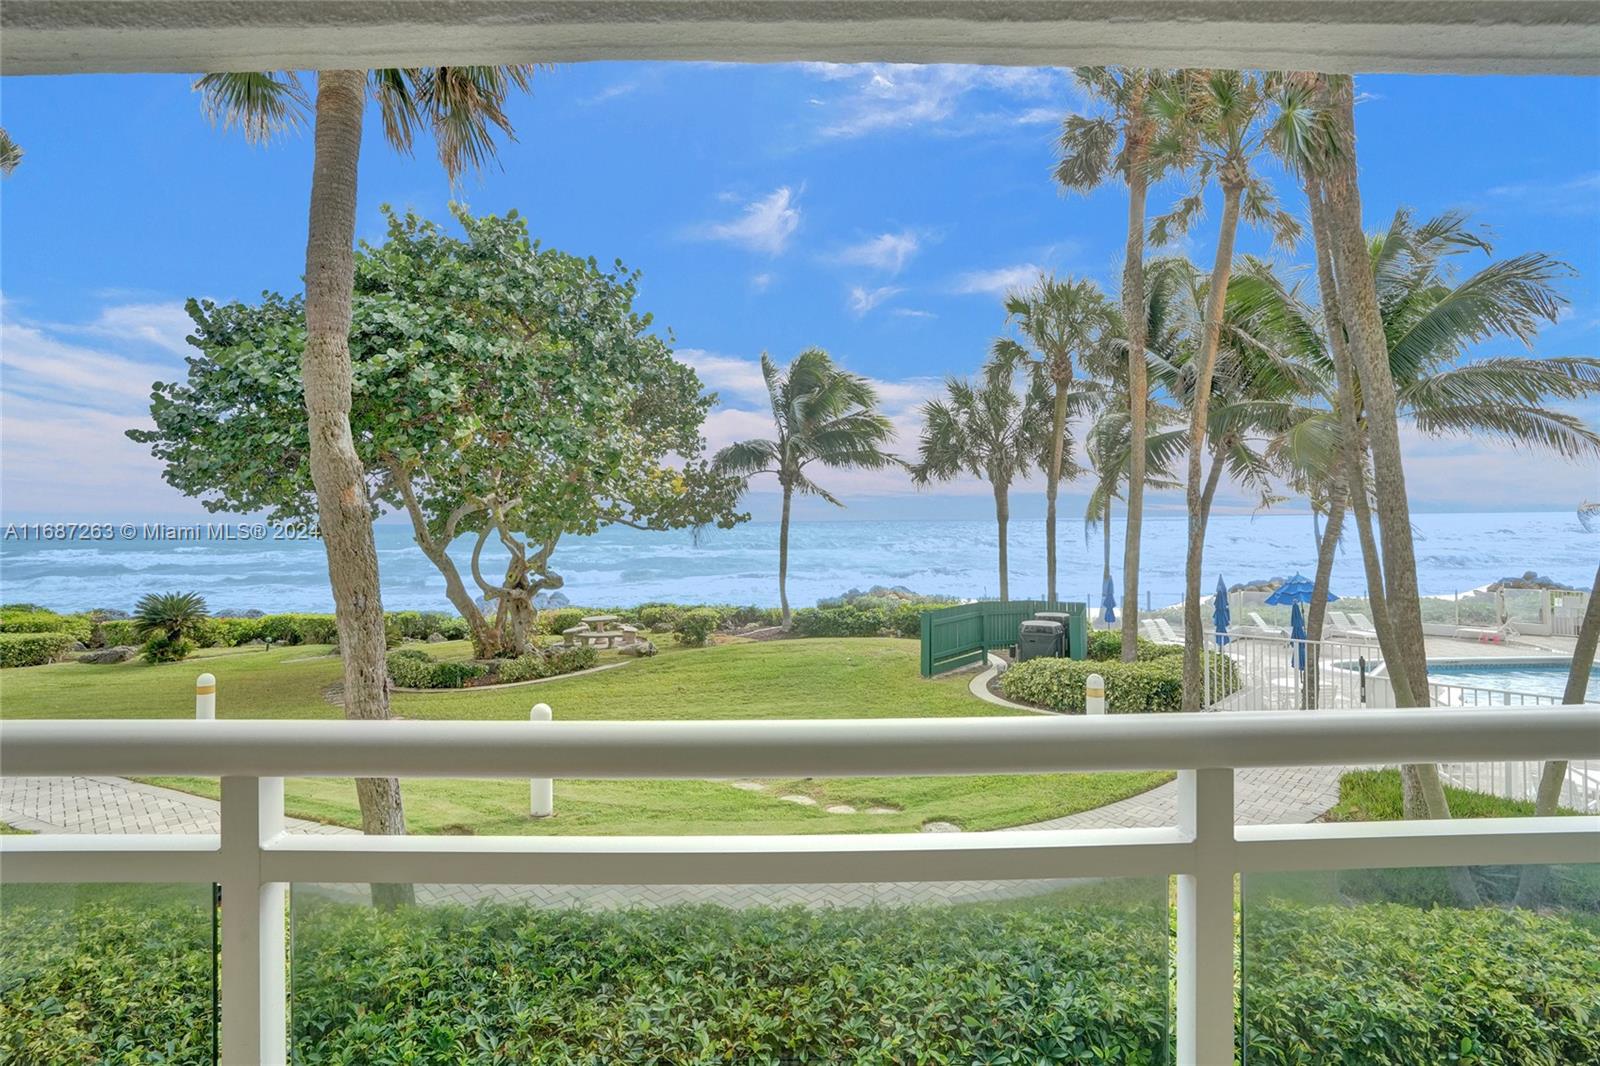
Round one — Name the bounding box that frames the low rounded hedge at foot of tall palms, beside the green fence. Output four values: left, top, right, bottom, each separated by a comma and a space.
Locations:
1000, 648, 1240, 714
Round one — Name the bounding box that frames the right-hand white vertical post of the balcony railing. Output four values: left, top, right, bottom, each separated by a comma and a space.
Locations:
1178, 770, 1235, 1066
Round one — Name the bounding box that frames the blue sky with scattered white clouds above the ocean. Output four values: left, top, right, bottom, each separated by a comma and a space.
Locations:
0, 64, 1600, 520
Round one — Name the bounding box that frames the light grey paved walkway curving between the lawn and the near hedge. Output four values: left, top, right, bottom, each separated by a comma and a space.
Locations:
0, 767, 1341, 909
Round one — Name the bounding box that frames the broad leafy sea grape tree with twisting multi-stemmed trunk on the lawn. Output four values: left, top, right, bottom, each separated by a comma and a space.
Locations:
128, 206, 744, 655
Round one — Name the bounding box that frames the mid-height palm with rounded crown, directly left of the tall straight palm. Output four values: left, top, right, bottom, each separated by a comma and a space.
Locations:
990, 277, 1117, 603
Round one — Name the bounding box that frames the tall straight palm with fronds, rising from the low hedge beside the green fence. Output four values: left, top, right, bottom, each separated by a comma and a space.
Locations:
1056, 67, 1163, 663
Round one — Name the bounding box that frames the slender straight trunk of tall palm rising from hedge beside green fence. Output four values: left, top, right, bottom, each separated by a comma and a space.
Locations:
1122, 89, 1150, 663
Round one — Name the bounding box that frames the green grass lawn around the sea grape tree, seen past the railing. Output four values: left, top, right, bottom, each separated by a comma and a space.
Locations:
0, 639, 1170, 834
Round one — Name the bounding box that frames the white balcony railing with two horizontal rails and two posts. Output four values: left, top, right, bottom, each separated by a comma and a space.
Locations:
0, 706, 1600, 1063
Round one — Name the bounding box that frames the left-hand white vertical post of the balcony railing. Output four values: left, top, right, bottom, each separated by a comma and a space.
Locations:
221, 778, 288, 1066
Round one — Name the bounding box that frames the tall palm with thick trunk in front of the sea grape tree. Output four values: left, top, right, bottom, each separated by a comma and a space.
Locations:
195, 66, 533, 903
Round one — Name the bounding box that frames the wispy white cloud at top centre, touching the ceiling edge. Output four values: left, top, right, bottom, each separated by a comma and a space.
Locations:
802, 62, 1077, 138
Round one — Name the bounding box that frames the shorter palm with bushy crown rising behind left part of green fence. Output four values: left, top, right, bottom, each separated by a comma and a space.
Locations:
910, 365, 1051, 600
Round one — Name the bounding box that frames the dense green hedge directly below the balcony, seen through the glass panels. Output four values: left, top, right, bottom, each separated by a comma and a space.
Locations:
0, 887, 1600, 1066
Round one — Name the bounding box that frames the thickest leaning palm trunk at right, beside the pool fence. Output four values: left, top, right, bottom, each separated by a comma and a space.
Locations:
1323, 78, 1475, 832
